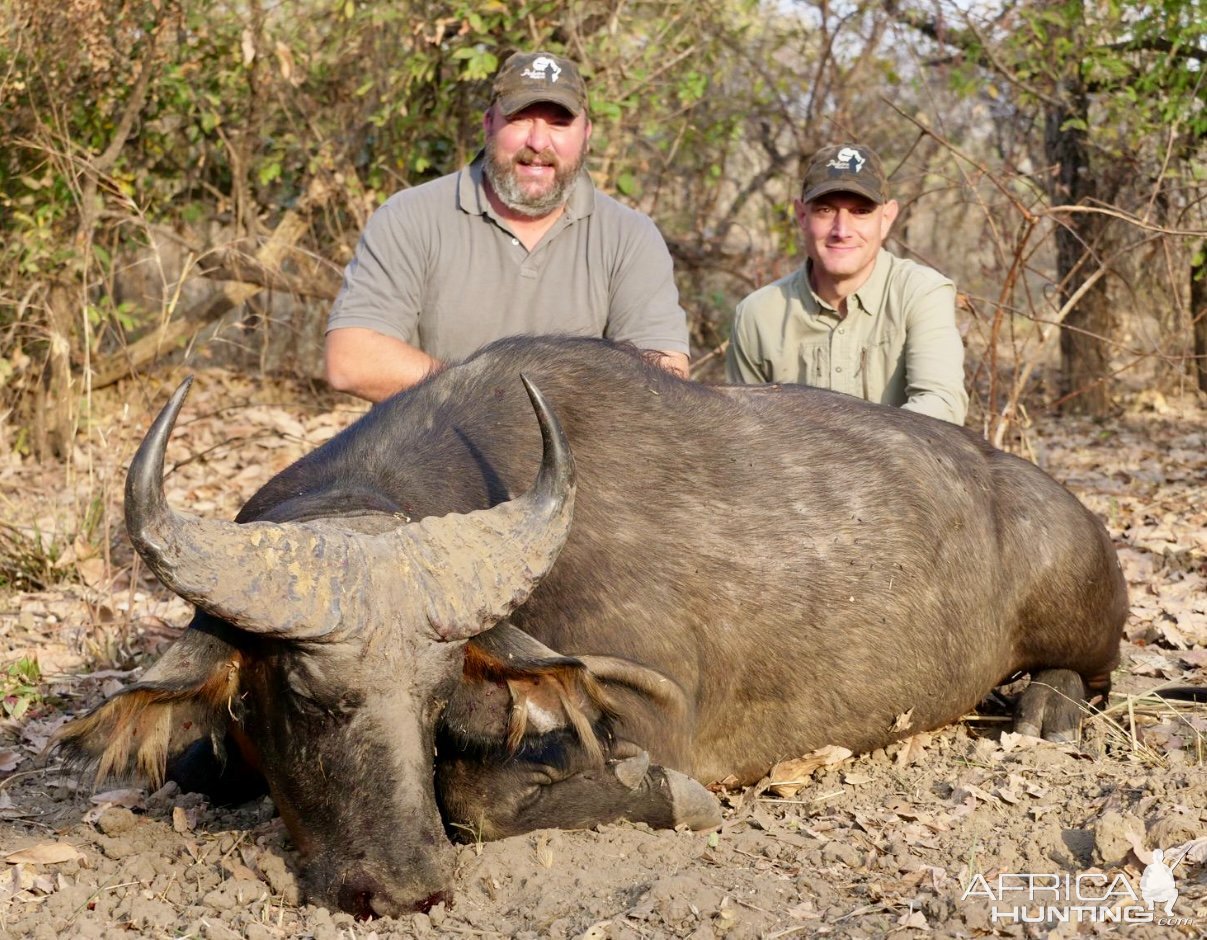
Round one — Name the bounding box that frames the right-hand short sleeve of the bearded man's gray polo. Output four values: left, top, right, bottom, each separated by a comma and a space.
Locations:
604, 210, 690, 354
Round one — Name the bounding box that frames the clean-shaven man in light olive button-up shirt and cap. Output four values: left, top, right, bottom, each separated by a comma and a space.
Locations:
725, 144, 968, 425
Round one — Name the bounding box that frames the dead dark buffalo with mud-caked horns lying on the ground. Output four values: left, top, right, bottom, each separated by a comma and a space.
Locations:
59, 339, 1127, 915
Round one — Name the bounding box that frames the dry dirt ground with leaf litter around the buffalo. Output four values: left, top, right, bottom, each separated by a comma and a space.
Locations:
0, 370, 1207, 940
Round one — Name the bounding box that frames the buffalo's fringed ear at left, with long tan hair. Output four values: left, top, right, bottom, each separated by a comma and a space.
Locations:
46, 630, 241, 789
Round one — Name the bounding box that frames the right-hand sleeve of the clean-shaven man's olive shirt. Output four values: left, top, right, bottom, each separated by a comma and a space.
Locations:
902, 280, 968, 425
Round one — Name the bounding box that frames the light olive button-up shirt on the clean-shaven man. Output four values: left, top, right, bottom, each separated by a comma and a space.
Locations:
725, 250, 968, 425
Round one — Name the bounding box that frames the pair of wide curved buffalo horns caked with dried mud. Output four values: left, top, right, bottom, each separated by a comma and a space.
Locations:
126, 376, 575, 640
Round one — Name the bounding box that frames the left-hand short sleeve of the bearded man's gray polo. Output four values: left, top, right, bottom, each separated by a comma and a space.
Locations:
327, 192, 425, 343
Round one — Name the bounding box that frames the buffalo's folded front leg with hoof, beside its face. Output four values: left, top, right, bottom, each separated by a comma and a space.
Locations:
437, 752, 721, 840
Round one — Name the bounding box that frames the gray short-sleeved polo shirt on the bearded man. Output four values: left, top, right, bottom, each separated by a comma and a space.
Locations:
327, 154, 688, 361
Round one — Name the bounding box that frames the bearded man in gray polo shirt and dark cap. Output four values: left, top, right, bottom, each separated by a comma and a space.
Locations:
326, 52, 688, 402
